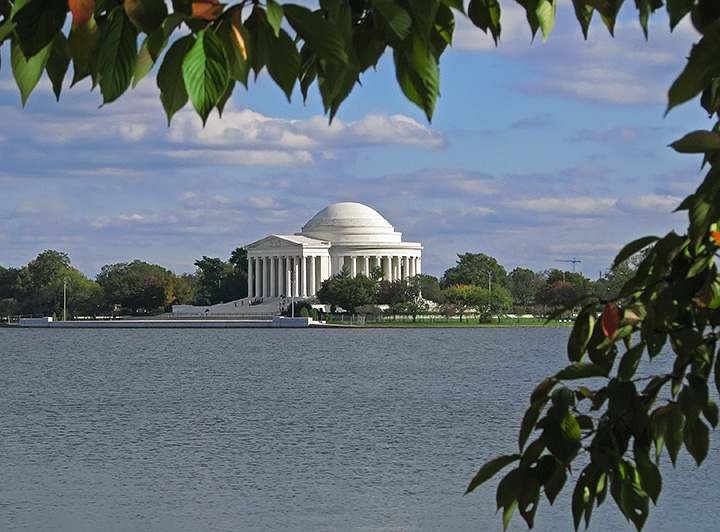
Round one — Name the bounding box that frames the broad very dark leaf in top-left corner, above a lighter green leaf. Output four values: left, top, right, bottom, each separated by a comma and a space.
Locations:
13, 0, 68, 57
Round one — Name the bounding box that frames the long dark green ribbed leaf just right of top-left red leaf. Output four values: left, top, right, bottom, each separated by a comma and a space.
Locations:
96, 6, 137, 103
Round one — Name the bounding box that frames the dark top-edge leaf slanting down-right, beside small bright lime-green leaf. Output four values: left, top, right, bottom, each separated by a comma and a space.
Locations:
283, 4, 349, 64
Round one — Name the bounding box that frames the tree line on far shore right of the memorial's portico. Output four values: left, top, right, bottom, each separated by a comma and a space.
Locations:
317, 253, 638, 322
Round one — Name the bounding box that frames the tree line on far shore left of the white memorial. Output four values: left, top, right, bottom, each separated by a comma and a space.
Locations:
0, 248, 247, 318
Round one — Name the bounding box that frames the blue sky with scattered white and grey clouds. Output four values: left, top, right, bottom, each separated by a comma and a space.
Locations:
0, 0, 712, 279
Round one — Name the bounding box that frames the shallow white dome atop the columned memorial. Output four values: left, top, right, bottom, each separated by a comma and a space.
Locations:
298, 201, 402, 243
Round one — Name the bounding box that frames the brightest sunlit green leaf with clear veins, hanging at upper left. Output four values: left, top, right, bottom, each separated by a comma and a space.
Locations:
182, 28, 230, 125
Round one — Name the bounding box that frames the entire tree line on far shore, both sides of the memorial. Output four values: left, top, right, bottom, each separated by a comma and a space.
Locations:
0, 248, 633, 321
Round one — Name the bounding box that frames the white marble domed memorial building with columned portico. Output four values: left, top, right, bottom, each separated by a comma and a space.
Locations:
245, 202, 423, 298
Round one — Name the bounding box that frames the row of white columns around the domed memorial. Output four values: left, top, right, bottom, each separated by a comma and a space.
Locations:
248, 255, 422, 298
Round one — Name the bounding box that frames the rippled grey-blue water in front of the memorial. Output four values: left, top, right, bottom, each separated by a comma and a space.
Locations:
0, 328, 720, 532
